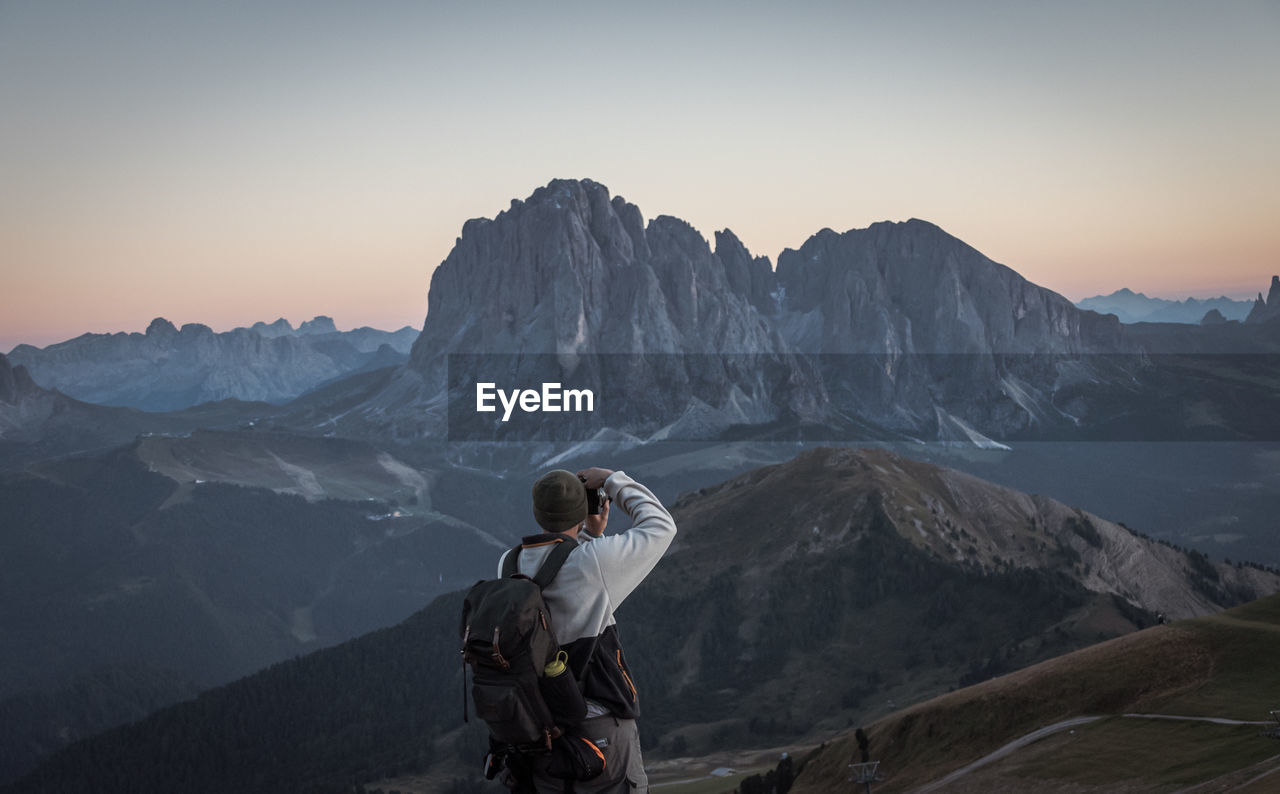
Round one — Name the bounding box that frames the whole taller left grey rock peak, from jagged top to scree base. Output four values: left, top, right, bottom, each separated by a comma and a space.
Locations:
411, 181, 822, 432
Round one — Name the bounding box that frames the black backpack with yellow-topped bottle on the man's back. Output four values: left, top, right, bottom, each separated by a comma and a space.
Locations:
458, 537, 586, 753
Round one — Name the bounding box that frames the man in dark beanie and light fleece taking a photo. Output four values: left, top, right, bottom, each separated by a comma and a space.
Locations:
498, 467, 676, 794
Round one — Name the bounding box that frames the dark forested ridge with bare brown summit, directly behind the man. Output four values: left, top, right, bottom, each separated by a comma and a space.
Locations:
9, 448, 1280, 791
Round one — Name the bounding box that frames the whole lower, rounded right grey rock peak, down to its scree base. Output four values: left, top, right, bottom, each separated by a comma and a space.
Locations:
776, 220, 1120, 441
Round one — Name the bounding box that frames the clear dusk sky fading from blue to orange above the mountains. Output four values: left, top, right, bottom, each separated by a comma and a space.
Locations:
0, 0, 1280, 351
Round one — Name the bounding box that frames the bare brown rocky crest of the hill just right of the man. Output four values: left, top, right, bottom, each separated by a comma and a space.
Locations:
672, 447, 1280, 617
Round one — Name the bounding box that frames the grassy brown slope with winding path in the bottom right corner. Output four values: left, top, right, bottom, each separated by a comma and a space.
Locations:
792, 596, 1280, 794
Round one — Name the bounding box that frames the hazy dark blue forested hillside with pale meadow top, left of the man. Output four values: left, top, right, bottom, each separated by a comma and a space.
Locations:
0, 437, 511, 780
